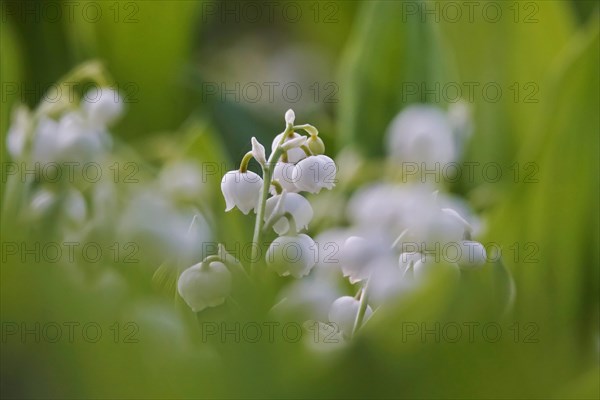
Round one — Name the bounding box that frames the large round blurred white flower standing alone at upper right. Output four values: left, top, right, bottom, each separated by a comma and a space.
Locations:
387, 105, 456, 170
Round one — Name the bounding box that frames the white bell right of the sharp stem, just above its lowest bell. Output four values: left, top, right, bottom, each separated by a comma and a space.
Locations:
265, 193, 313, 235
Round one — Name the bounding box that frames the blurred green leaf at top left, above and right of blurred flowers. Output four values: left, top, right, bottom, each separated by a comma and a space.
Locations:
72, 1, 201, 137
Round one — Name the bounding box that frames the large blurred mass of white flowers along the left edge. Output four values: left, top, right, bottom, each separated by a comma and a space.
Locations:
2, 62, 210, 265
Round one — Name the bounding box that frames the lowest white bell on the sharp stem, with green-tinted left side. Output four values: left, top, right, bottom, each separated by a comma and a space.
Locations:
266, 234, 317, 278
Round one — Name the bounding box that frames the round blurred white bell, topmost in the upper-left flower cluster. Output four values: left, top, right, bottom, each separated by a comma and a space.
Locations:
81, 87, 124, 126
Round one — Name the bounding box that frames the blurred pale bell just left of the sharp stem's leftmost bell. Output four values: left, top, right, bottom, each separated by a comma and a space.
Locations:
159, 161, 205, 202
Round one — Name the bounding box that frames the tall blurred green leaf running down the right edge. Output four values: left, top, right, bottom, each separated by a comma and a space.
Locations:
490, 21, 600, 361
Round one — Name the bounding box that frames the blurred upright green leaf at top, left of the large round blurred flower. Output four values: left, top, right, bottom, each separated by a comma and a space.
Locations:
338, 1, 453, 156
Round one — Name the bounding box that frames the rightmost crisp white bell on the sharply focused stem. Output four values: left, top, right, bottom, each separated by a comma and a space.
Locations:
292, 155, 337, 193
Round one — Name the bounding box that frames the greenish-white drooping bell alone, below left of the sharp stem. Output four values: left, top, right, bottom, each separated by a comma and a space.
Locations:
177, 261, 231, 312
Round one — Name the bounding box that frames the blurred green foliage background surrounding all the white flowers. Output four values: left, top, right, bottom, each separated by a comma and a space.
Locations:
0, 0, 600, 398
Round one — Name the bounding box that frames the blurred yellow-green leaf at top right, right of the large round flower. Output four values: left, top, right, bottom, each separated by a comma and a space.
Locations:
440, 1, 574, 192
